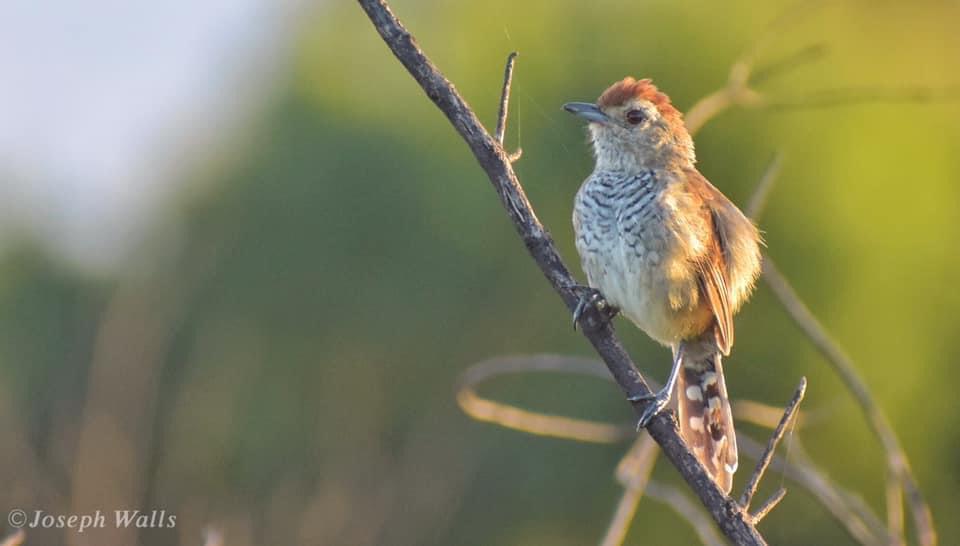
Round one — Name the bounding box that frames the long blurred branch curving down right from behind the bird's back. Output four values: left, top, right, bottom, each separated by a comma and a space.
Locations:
763, 256, 937, 546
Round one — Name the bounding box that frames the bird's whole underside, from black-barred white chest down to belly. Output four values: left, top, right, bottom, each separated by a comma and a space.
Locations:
573, 170, 698, 344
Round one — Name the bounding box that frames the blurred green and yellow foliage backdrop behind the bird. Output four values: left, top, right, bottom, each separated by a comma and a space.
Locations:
0, 0, 960, 546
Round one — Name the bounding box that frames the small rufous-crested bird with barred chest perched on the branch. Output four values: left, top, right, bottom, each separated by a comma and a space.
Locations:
563, 77, 762, 494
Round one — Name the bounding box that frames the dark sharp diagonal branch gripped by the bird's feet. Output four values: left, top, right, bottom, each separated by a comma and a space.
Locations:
359, 0, 766, 545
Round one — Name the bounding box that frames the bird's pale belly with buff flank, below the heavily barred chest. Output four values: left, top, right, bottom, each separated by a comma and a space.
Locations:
578, 223, 710, 345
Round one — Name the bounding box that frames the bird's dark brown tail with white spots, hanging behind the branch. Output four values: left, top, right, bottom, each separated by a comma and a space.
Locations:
677, 335, 737, 493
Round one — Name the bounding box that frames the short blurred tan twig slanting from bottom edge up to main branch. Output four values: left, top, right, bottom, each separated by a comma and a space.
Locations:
600, 434, 660, 546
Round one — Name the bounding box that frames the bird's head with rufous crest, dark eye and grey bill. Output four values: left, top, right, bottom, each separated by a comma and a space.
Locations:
563, 77, 696, 171
